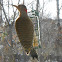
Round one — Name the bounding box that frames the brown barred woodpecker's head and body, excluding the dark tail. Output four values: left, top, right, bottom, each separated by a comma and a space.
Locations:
13, 4, 34, 54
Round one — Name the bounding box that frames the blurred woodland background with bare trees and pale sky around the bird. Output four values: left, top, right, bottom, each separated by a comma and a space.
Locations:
0, 0, 62, 62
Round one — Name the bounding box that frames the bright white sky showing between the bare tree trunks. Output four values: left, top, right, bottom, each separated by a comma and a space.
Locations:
3, 0, 62, 18
